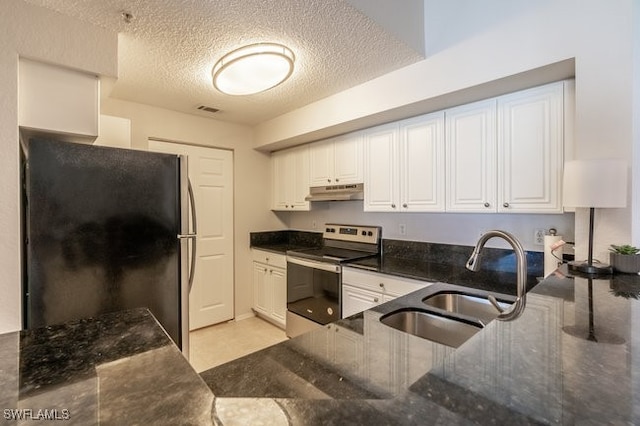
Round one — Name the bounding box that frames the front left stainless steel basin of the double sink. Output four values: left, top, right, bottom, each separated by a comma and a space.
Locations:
380, 308, 482, 348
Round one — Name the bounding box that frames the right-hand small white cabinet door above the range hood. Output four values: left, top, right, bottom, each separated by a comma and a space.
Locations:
334, 133, 364, 184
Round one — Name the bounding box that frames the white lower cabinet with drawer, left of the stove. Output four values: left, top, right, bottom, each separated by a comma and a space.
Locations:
251, 249, 287, 328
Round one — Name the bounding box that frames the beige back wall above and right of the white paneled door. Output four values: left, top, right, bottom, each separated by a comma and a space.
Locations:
102, 99, 283, 317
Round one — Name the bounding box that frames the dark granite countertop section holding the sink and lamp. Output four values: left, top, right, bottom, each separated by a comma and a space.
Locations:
202, 268, 640, 425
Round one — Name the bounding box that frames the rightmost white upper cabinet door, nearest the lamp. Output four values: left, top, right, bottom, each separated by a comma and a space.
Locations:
498, 83, 564, 213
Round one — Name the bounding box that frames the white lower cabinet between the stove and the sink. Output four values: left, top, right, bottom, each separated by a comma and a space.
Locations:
342, 267, 429, 318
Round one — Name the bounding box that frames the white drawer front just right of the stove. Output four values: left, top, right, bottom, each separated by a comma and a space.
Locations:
342, 267, 430, 296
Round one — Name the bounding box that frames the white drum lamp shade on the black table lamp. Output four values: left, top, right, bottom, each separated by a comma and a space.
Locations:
563, 159, 627, 208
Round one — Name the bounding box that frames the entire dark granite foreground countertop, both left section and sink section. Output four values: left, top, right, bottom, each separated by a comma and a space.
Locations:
5, 268, 640, 425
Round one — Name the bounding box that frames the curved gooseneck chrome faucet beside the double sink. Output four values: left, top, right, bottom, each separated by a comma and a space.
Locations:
466, 230, 527, 321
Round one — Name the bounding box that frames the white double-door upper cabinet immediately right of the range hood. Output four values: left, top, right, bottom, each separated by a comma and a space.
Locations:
364, 112, 445, 212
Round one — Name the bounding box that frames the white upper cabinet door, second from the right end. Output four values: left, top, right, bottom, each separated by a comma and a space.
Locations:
445, 99, 497, 213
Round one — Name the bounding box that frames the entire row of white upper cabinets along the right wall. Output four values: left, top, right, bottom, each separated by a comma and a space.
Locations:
273, 82, 571, 213
